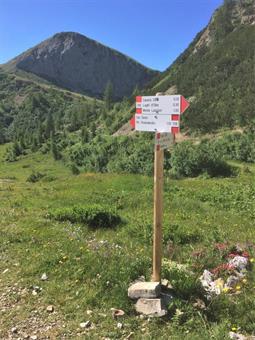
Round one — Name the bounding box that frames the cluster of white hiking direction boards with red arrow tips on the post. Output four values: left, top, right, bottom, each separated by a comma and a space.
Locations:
130, 95, 189, 134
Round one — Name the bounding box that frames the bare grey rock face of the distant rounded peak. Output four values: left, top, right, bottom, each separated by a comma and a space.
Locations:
9, 32, 157, 97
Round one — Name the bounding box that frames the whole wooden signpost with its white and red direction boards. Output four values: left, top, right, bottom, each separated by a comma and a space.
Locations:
130, 95, 189, 282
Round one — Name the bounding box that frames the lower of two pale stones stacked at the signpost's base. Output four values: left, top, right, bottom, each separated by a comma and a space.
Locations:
135, 298, 167, 317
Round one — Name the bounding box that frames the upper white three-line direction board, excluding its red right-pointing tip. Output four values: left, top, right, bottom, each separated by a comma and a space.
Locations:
136, 95, 181, 115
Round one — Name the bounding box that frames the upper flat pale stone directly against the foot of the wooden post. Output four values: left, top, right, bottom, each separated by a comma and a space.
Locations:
128, 282, 161, 299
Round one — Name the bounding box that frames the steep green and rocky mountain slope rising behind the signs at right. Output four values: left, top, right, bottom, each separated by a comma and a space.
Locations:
146, 0, 255, 132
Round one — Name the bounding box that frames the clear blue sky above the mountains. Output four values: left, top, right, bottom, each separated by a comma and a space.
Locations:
0, 0, 223, 70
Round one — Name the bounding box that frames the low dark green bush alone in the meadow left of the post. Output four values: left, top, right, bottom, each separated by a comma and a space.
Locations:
49, 205, 121, 228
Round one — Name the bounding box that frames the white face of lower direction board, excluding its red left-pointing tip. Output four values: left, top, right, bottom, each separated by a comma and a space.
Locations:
135, 114, 180, 132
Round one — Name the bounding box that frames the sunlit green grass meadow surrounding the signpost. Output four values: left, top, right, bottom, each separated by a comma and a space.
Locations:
0, 146, 255, 340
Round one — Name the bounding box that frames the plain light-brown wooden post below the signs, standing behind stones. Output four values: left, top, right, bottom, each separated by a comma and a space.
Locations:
152, 140, 164, 282
